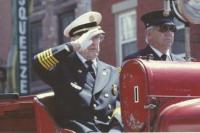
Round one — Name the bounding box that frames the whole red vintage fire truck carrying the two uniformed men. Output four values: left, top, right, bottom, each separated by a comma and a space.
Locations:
0, 0, 200, 133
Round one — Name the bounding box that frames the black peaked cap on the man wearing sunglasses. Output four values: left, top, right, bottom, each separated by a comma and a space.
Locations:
141, 10, 174, 27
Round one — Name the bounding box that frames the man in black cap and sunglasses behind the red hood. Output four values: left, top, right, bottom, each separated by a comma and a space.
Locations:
124, 10, 184, 61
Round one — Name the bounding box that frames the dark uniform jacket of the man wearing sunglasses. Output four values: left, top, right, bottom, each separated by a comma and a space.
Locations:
124, 45, 184, 61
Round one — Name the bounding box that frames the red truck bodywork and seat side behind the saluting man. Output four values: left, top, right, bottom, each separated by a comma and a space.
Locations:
0, 92, 73, 133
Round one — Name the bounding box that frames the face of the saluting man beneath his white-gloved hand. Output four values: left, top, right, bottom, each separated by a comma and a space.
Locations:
79, 34, 104, 60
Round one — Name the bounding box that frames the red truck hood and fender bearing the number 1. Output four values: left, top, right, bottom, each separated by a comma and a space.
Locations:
120, 59, 200, 131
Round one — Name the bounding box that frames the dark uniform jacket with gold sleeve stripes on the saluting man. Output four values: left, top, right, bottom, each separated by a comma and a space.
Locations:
33, 44, 121, 132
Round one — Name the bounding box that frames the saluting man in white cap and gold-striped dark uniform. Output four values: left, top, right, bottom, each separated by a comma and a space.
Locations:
33, 11, 122, 132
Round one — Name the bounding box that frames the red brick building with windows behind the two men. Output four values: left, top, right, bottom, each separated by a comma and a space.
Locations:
0, 0, 200, 93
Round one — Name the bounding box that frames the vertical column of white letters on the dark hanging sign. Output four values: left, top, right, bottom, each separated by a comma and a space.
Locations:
18, 0, 29, 94
